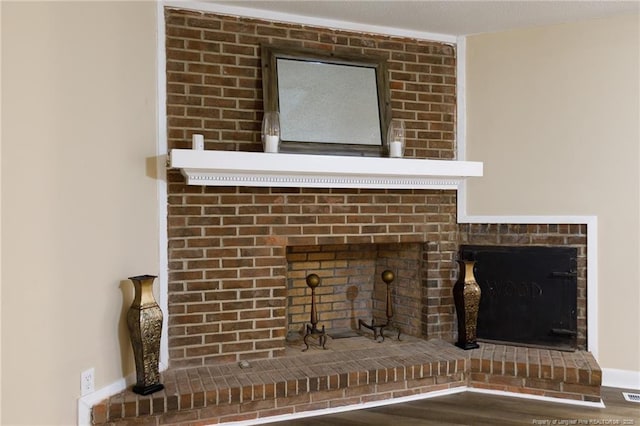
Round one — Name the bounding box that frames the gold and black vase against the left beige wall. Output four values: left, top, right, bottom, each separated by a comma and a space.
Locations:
127, 275, 164, 395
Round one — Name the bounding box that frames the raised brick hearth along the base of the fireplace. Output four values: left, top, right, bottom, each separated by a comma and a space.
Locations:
93, 337, 602, 425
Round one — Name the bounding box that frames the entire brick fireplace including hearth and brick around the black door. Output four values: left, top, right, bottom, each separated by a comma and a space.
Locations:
92, 9, 601, 425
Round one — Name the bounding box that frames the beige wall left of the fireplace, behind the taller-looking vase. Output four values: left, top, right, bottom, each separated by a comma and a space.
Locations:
1, 2, 159, 425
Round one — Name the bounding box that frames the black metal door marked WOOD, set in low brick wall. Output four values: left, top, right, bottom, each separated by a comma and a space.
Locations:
460, 245, 578, 350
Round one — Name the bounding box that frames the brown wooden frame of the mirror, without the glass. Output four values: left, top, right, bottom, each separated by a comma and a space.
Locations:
261, 44, 391, 157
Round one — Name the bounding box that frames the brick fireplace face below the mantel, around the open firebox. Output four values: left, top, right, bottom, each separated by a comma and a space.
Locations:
169, 185, 457, 367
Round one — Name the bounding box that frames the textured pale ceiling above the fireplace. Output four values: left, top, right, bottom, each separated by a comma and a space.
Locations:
209, 0, 640, 36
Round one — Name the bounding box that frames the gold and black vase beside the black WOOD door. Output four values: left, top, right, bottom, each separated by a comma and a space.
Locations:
453, 260, 481, 350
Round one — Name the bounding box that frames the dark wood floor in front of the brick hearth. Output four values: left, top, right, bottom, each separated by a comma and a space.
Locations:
270, 387, 640, 426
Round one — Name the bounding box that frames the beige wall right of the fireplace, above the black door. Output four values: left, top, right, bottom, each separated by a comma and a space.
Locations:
466, 15, 640, 372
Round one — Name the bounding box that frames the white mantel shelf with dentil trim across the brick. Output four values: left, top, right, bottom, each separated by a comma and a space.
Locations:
170, 149, 482, 189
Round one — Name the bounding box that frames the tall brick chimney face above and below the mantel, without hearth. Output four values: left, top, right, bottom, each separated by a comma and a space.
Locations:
166, 5, 457, 367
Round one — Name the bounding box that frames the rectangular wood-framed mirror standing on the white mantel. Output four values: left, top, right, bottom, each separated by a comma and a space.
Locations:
261, 44, 391, 157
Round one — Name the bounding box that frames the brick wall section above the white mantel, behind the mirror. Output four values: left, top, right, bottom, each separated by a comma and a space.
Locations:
166, 9, 456, 158
